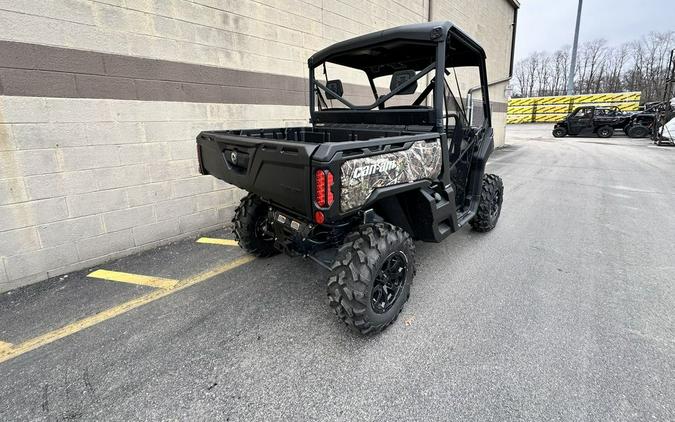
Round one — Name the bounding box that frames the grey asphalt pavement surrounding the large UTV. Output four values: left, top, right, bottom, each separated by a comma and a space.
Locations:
0, 125, 675, 421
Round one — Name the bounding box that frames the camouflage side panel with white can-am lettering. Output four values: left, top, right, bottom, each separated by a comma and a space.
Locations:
340, 139, 441, 212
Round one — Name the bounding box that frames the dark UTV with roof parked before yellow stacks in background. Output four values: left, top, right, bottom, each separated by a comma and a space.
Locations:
553, 106, 649, 138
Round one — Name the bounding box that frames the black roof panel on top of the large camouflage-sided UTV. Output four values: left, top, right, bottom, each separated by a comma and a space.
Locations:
308, 21, 485, 77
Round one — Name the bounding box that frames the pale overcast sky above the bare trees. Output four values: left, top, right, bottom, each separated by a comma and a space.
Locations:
515, 0, 675, 61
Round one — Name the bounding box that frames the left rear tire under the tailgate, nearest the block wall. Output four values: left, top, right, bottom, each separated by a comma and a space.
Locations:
232, 193, 278, 257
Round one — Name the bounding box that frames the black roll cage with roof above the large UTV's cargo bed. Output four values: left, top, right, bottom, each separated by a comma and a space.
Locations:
308, 21, 491, 133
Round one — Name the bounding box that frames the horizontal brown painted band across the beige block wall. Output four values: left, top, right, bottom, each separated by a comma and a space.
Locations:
0, 41, 506, 112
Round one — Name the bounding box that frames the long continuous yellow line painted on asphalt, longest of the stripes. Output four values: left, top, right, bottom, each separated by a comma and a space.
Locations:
0, 255, 255, 363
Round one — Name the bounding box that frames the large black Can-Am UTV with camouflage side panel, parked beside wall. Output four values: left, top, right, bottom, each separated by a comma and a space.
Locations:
197, 22, 503, 334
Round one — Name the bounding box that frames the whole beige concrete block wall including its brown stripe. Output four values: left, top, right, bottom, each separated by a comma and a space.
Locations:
0, 0, 513, 291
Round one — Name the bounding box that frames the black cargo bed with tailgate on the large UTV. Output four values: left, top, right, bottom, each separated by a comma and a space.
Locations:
197, 125, 438, 220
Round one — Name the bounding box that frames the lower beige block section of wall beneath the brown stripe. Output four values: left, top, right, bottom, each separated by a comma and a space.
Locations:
0, 97, 305, 290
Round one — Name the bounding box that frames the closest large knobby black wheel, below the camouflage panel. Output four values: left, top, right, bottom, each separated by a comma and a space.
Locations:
328, 223, 415, 334
